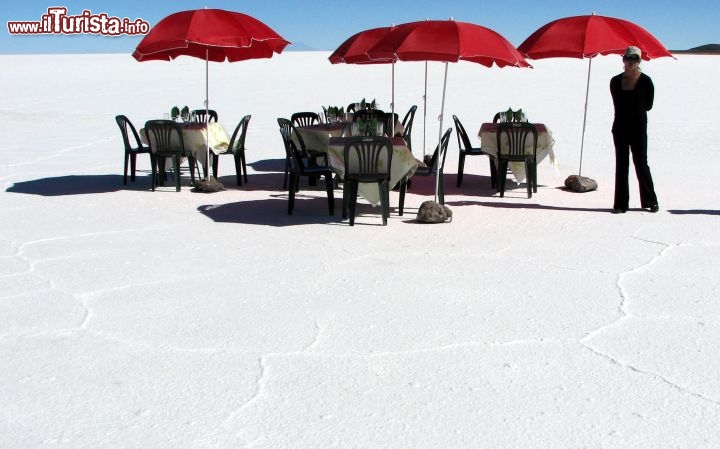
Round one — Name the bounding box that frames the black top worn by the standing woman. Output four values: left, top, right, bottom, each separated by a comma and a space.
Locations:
610, 73, 655, 133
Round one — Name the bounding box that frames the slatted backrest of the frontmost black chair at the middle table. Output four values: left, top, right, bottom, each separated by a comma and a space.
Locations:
343, 136, 393, 182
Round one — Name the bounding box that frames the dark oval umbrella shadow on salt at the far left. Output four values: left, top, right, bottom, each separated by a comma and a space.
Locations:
5, 173, 151, 196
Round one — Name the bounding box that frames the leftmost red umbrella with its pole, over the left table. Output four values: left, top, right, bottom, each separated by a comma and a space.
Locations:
133, 9, 290, 187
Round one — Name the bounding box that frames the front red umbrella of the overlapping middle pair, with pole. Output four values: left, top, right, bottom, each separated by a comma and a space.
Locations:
367, 20, 530, 199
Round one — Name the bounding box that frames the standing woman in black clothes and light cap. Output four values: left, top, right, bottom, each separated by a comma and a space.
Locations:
610, 46, 659, 214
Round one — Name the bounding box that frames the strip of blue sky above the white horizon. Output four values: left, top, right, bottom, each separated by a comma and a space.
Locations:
0, 0, 720, 54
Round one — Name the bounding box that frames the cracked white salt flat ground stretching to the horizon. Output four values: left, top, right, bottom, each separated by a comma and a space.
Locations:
0, 52, 720, 449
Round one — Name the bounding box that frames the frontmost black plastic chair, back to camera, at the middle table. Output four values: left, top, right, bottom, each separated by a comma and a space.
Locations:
343, 136, 393, 226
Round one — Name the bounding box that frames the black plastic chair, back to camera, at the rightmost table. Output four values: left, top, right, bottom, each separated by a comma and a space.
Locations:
497, 122, 537, 198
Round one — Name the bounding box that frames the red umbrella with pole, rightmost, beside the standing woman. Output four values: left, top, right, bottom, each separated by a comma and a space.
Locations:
518, 14, 672, 175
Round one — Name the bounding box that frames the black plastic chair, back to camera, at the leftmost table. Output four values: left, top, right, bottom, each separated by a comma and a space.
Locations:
145, 120, 195, 192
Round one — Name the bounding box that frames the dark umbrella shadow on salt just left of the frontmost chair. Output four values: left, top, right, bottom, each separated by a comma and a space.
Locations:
197, 193, 342, 227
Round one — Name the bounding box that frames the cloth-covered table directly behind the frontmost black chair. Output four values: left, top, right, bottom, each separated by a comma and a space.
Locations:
327, 137, 423, 206
